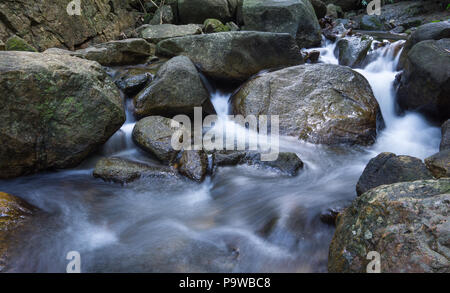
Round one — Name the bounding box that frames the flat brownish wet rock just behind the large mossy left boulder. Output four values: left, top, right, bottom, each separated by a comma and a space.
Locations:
71, 39, 155, 66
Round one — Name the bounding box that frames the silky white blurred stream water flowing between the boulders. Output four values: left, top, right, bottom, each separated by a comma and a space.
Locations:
0, 38, 440, 272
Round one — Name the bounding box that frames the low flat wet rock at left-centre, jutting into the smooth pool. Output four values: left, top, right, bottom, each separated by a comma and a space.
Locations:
93, 157, 177, 184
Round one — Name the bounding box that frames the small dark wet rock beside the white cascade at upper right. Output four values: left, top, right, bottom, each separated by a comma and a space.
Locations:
336, 36, 372, 68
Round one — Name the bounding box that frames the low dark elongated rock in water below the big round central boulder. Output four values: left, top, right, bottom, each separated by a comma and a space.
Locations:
212, 151, 303, 176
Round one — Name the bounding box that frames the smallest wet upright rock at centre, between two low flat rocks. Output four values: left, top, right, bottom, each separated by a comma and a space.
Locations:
178, 150, 208, 182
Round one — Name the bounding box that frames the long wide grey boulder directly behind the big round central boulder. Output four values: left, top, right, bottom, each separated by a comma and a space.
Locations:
157, 31, 303, 81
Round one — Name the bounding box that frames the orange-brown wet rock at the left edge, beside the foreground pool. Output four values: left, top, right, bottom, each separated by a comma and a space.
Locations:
0, 192, 38, 272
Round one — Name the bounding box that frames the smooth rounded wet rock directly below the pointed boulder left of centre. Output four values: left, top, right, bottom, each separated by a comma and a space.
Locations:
133, 116, 185, 163
